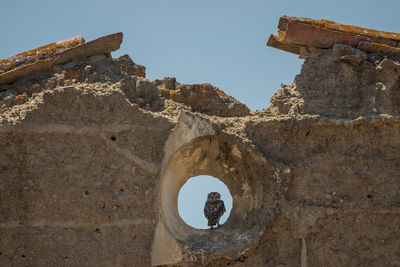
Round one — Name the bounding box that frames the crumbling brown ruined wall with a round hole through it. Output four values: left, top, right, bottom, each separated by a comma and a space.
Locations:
0, 17, 400, 266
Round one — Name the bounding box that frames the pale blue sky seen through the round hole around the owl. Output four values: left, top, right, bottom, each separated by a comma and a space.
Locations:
178, 175, 233, 229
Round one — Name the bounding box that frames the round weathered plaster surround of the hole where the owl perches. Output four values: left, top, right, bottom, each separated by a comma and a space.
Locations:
160, 136, 288, 253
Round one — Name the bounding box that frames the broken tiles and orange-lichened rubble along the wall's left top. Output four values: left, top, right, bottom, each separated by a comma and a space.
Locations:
0, 33, 250, 117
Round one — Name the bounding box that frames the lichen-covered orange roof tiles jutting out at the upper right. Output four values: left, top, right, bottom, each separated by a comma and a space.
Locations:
267, 16, 400, 55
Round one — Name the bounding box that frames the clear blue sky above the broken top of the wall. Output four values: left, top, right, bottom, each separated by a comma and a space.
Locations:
0, 0, 400, 229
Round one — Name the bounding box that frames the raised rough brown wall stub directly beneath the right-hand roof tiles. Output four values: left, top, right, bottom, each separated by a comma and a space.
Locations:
270, 44, 400, 118
